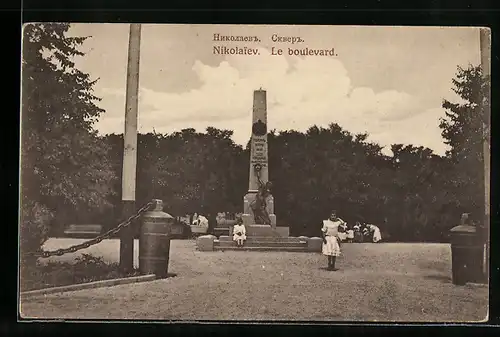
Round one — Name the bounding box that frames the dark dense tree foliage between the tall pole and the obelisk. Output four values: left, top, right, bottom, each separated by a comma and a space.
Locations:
105, 128, 248, 222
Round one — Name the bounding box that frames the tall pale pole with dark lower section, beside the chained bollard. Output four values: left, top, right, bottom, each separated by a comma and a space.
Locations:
120, 24, 141, 272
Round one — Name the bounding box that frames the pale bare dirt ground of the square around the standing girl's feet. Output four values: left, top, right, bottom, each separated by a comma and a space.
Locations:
21, 239, 488, 322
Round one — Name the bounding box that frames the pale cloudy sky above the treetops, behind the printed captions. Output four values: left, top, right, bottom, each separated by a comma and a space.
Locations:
70, 24, 480, 154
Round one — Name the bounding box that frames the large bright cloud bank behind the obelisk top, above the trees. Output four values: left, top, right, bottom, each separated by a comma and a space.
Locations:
97, 48, 450, 153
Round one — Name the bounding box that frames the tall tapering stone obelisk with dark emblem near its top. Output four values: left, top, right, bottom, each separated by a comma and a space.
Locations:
243, 89, 276, 232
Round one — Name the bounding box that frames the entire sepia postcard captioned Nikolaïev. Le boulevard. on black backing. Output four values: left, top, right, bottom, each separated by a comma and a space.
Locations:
18, 23, 491, 323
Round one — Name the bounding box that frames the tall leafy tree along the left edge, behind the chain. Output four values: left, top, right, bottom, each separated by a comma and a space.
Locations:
21, 23, 116, 255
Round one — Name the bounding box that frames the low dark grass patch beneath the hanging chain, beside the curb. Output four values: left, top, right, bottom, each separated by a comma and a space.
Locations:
20, 254, 139, 291
